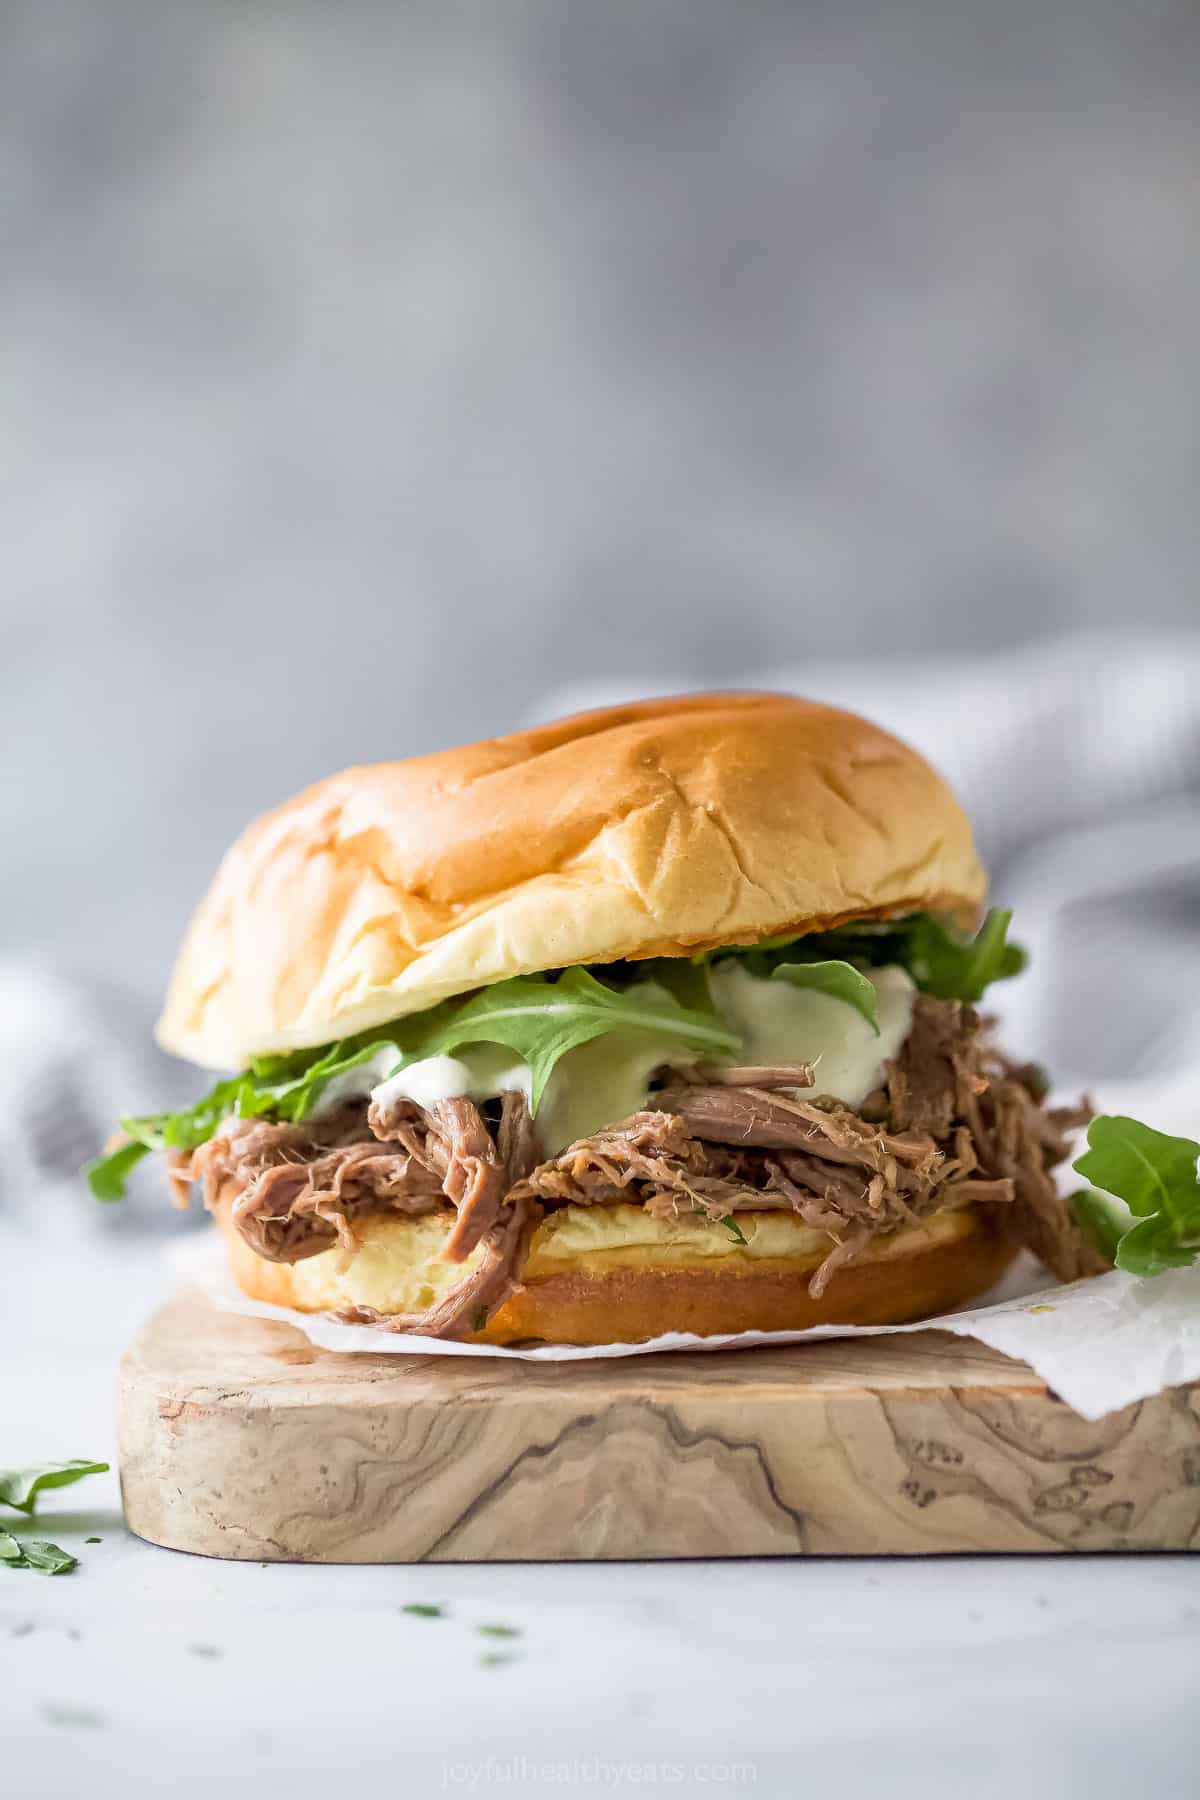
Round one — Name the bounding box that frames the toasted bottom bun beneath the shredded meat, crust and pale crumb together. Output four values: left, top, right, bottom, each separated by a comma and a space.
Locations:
208, 1204, 1013, 1345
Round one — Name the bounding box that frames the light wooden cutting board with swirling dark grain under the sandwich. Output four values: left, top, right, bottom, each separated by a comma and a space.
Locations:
119, 1294, 1200, 1562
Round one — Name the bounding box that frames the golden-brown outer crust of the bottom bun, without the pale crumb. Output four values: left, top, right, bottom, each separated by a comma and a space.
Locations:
218, 1206, 1015, 1345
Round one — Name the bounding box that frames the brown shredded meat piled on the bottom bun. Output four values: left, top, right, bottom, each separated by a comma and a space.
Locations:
171, 995, 1105, 1337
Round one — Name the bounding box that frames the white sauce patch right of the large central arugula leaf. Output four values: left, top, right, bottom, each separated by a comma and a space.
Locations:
712, 958, 916, 1107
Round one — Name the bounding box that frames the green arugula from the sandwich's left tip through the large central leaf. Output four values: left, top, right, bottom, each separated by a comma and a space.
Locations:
85, 963, 741, 1201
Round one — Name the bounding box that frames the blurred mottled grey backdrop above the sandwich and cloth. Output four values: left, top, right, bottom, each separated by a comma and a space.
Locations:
0, 0, 1200, 1003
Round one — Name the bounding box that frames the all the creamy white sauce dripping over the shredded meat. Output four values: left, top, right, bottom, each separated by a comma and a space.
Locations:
356, 958, 916, 1156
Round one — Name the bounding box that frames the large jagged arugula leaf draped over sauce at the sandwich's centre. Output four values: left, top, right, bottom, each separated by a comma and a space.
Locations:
402, 968, 741, 1112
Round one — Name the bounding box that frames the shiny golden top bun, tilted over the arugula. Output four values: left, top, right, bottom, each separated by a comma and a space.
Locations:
158, 693, 984, 1069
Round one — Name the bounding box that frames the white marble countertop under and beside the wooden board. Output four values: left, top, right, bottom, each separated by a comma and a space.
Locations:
0, 1233, 1200, 1800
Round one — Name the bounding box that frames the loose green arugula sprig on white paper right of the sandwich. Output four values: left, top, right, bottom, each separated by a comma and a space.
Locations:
1074, 1114, 1200, 1274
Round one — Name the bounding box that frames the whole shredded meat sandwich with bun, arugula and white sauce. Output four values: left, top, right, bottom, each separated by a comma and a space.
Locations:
90, 693, 1195, 1345
